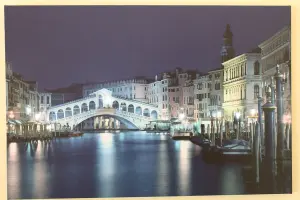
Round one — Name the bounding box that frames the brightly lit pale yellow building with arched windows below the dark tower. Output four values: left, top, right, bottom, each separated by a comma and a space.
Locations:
223, 49, 262, 121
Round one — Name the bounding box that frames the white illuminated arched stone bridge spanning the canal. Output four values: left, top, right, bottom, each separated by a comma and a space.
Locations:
47, 89, 160, 129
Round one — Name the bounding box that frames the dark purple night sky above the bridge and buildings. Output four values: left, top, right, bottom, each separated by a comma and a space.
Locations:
5, 6, 290, 89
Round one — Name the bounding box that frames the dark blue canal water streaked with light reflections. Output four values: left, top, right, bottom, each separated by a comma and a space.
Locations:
7, 132, 244, 199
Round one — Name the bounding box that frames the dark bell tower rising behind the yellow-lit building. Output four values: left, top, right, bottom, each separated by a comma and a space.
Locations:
221, 24, 235, 63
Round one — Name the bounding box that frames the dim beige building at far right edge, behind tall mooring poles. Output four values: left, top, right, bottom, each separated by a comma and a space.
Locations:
259, 26, 291, 114
